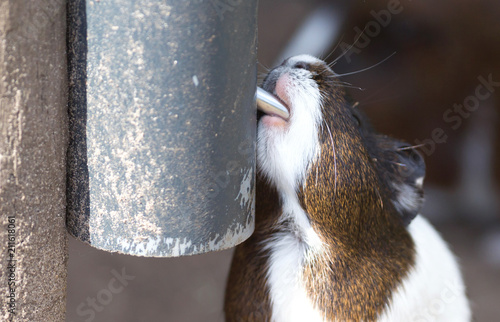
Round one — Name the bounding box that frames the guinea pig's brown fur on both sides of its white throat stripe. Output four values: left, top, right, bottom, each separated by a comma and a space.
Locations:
225, 61, 414, 321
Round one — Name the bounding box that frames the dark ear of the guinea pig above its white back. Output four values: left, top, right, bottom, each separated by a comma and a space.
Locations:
392, 142, 425, 225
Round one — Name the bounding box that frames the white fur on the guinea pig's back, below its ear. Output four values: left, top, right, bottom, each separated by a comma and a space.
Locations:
379, 215, 471, 322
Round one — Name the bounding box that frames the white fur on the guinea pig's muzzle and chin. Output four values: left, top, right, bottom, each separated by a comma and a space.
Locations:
257, 55, 322, 193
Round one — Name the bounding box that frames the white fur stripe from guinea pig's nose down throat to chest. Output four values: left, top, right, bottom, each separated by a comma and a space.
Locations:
257, 55, 330, 322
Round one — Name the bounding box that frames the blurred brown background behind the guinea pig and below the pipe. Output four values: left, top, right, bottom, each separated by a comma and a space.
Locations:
67, 0, 500, 322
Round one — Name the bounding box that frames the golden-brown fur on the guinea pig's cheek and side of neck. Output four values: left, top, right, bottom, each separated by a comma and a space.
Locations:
298, 101, 414, 321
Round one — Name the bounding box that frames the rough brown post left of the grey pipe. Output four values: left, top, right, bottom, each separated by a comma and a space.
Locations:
0, 0, 68, 321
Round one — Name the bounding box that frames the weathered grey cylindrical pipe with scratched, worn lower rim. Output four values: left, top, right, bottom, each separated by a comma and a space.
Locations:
67, 0, 257, 256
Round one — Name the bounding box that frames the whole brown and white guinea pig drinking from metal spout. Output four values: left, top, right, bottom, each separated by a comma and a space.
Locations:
225, 55, 471, 322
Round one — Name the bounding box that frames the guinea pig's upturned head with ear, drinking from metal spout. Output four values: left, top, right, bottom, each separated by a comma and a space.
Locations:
257, 55, 425, 239
